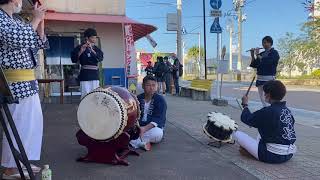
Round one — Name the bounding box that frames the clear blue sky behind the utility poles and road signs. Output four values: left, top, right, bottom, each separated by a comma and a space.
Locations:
126, 0, 308, 57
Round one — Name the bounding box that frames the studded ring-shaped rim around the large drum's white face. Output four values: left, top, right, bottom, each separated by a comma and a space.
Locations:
78, 87, 128, 142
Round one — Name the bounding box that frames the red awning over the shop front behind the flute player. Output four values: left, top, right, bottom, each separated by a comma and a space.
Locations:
45, 12, 157, 41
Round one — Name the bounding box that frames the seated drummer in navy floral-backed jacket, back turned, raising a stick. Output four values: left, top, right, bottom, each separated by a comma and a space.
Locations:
233, 80, 296, 163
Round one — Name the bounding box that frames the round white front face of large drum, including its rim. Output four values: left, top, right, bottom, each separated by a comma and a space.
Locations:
77, 90, 127, 140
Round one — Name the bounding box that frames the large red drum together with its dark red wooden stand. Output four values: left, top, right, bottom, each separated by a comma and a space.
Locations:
76, 87, 140, 165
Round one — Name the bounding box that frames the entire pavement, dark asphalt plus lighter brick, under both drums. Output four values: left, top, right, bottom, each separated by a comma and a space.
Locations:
0, 87, 320, 180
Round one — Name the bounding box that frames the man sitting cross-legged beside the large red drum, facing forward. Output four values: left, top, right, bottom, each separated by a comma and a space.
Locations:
130, 76, 167, 151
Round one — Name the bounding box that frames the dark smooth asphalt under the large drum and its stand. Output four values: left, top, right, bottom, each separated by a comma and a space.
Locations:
11, 104, 257, 180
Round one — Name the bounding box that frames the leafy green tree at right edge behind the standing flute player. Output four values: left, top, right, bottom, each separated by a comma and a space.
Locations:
278, 1, 320, 77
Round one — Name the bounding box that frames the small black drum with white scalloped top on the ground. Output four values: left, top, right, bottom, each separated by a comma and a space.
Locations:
203, 112, 238, 143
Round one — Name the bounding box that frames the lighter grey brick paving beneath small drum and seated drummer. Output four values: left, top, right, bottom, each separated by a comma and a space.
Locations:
166, 96, 320, 180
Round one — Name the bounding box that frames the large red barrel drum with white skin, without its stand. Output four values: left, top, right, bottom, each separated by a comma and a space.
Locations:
77, 87, 140, 141
